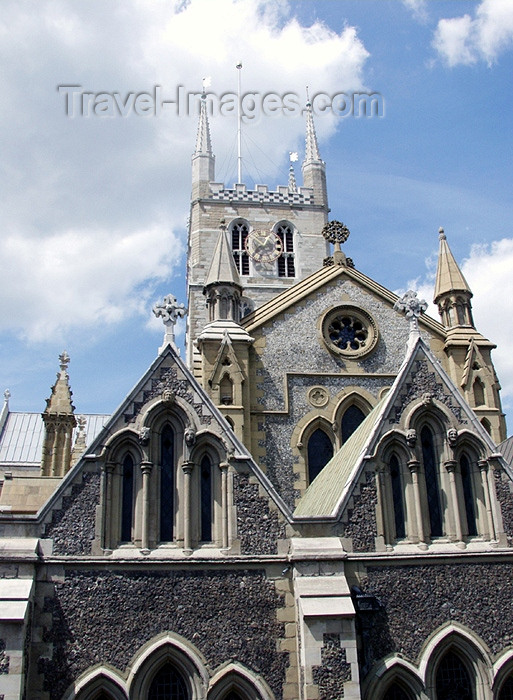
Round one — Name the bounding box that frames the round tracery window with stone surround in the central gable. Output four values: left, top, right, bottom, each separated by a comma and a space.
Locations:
322, 306, 378, 357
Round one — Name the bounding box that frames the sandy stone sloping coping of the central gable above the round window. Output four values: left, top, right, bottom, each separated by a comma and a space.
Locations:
241, 265, 446, 339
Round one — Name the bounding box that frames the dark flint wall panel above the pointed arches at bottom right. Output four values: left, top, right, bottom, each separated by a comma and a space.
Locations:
362, 563, 513, 663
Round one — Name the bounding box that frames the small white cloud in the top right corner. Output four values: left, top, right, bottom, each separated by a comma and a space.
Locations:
433, 0, 513, 66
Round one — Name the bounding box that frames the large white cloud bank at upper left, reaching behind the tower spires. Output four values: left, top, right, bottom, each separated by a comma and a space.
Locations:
0, 0, 368, 341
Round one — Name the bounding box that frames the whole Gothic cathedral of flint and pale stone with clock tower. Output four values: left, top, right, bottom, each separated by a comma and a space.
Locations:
0, 94, 513, 700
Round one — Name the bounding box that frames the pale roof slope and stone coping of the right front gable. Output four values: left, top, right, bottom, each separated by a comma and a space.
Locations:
294, 337, 502, 520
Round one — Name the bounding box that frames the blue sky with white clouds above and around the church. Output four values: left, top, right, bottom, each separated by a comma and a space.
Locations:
0, 0, 513, 432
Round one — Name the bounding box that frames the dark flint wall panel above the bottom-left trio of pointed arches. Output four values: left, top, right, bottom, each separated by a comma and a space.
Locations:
38, 570, 288, 700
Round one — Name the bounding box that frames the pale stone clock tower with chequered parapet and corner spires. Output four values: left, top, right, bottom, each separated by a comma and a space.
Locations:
186, 95, 329, 376
